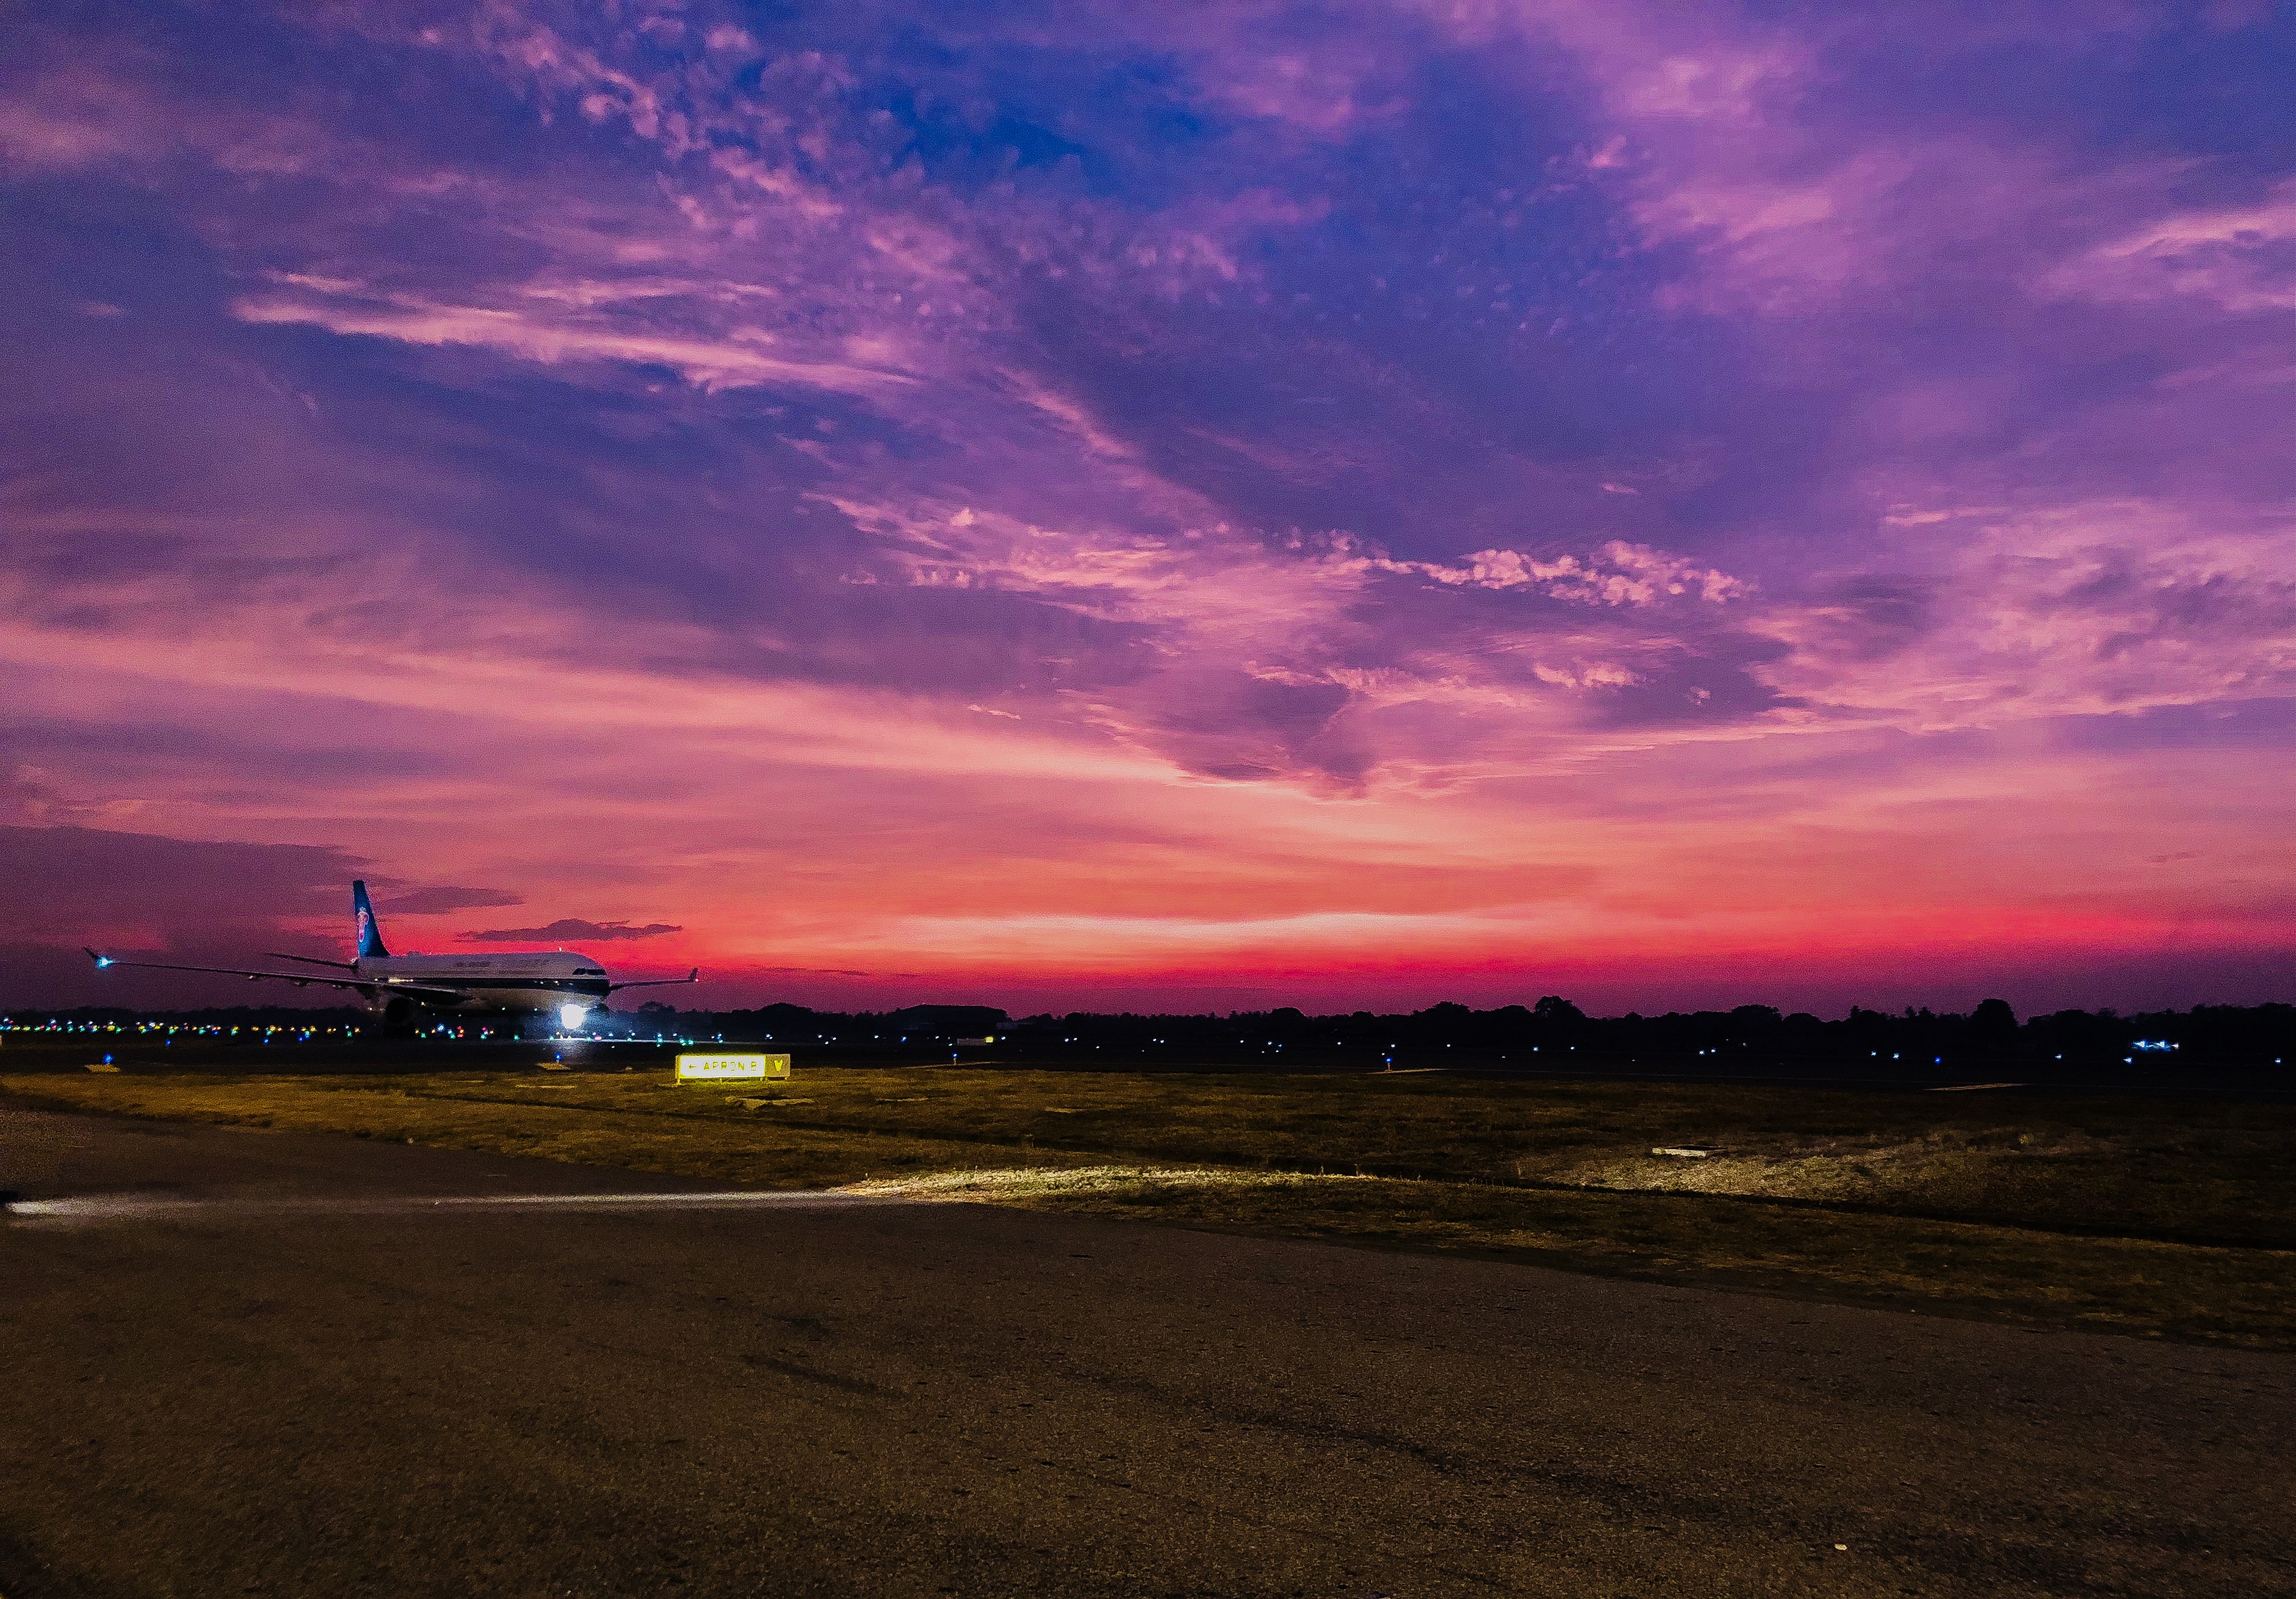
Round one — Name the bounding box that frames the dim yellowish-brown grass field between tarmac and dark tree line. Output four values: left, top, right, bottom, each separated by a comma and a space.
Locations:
13, 1068, 2296, 1348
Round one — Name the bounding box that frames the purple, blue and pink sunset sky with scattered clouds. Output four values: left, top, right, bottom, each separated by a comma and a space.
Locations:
0, 0, 2296, 1013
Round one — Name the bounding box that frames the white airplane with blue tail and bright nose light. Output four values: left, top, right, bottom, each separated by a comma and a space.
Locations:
87, 882, 703, 1031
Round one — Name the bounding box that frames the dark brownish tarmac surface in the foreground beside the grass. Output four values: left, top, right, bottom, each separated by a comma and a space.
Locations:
0, 1110, 2296, 1599
